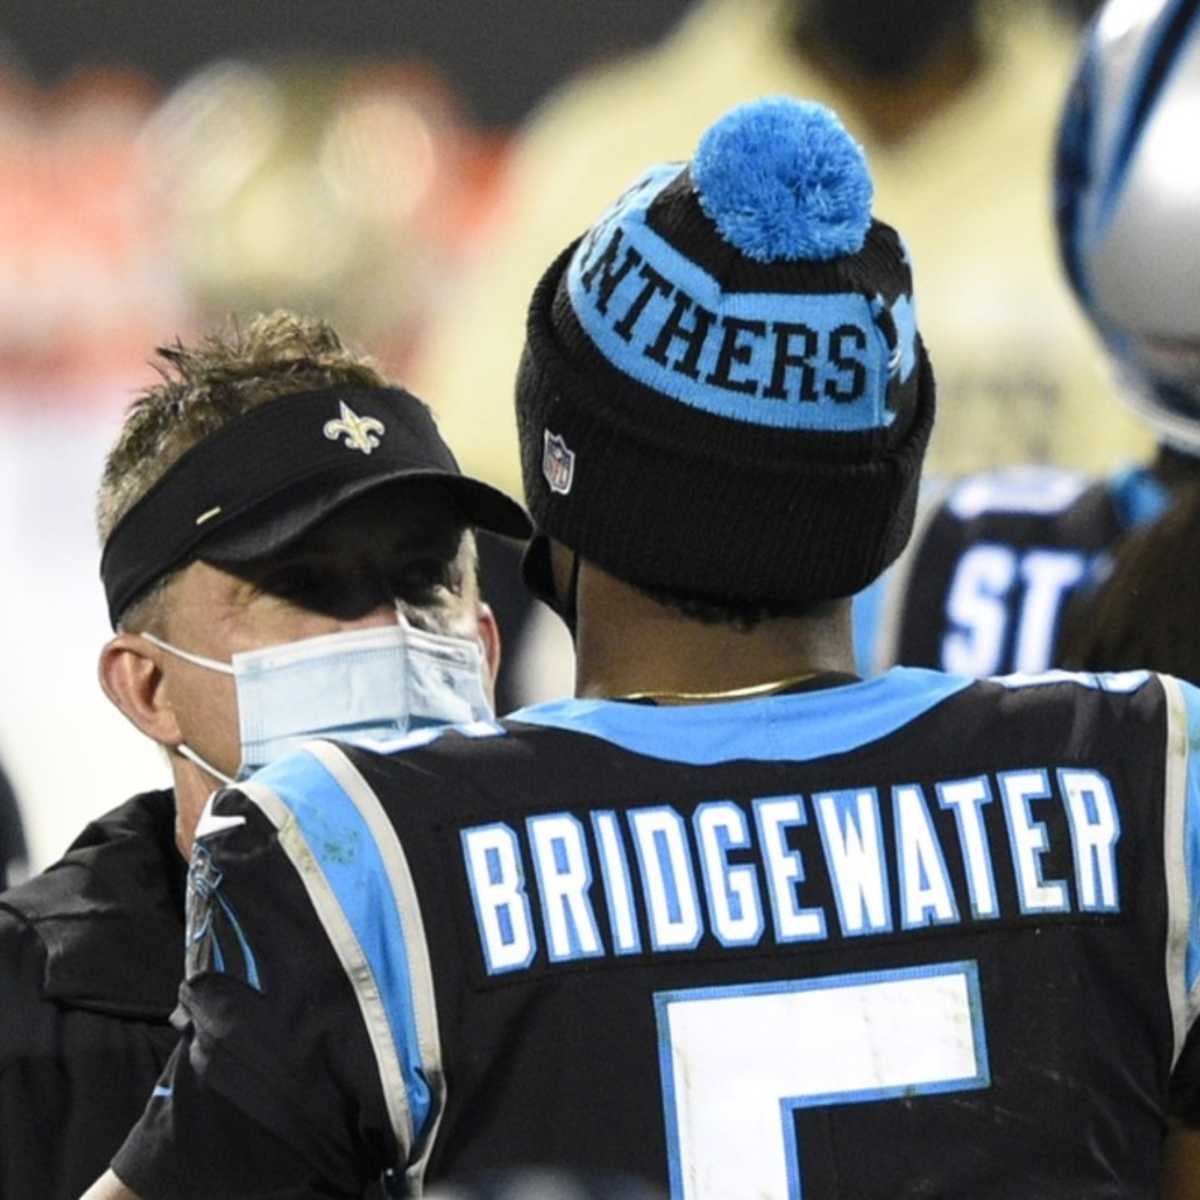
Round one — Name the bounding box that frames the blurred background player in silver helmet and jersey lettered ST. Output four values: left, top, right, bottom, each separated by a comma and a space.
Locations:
856, 0, 1200, 676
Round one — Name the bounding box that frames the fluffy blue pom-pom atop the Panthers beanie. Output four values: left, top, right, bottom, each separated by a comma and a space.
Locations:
691, 96, 874, 263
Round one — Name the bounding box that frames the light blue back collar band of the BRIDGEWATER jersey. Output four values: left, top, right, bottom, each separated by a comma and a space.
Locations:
510, 667, 974, 767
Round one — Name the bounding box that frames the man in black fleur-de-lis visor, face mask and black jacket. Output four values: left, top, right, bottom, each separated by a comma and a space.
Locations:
0, 313, 527, 1200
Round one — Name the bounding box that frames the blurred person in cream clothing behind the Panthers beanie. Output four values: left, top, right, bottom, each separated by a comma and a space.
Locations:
413, 0, 1123, 703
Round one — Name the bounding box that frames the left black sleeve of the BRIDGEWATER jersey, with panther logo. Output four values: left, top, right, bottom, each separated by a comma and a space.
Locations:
114, 793, 401, 1200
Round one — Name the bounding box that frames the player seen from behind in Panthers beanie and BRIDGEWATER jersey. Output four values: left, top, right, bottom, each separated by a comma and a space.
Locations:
89, 98, 1200, 1200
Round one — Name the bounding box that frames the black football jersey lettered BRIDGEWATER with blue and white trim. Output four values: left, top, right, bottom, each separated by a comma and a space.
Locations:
115, 668, 1200, 1200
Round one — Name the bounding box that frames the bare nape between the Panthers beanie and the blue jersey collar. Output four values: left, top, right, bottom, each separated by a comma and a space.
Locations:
575, 569, 854, 698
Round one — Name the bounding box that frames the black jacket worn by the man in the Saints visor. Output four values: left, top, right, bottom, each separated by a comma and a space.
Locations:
0, 791, 187, 1200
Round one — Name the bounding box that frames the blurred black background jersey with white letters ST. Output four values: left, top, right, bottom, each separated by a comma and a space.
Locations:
856, 467, 1166, 676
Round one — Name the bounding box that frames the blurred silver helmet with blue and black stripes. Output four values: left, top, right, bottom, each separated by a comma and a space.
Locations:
1055, 0, 1200, 455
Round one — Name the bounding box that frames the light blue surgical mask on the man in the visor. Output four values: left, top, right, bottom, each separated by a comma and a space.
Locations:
142, 608, 493, 784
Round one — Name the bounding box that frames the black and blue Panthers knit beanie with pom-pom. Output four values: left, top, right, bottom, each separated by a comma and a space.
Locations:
516, 97, 934, 613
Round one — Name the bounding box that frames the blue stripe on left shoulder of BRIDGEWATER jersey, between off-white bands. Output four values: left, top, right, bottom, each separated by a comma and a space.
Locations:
254, 752, 432, 1145
